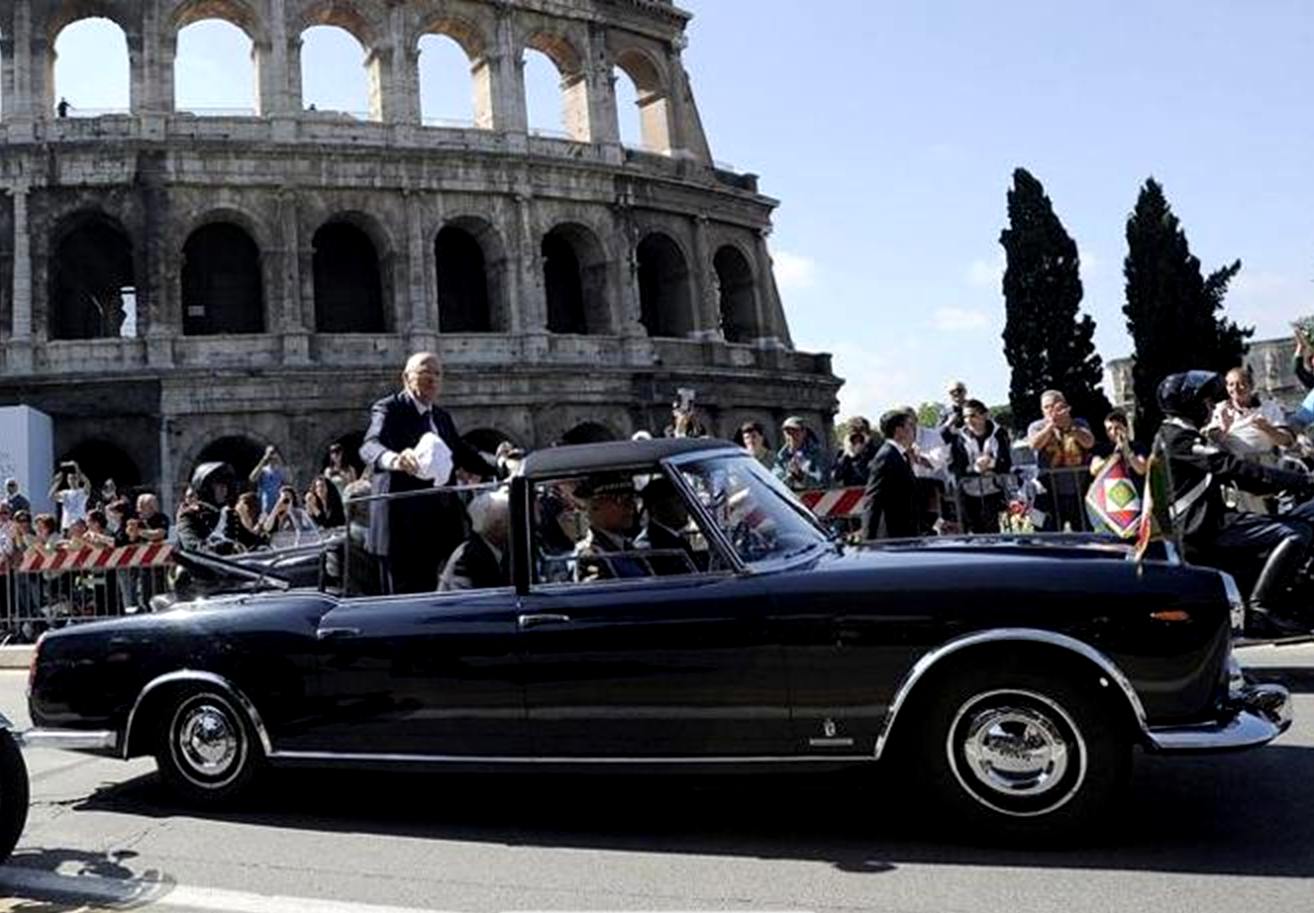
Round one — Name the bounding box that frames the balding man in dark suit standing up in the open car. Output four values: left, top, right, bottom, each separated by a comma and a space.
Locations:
360, 352, 495, 592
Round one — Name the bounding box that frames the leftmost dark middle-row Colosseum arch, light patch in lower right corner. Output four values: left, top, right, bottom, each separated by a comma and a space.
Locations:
50, 217, 137, 339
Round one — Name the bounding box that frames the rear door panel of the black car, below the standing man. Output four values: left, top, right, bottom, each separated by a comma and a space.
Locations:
280, 587, 528, 758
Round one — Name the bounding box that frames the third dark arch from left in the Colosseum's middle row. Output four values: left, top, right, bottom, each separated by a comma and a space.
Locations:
311, 222, 384, 332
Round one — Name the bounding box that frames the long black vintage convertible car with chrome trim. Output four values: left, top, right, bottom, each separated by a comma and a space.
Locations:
5, 440, 1290, 833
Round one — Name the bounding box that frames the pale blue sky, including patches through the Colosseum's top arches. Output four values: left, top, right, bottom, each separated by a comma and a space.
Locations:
38, 0, 1314, 415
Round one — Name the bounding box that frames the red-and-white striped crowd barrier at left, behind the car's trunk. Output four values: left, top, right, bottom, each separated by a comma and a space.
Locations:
0, 543, 173, 644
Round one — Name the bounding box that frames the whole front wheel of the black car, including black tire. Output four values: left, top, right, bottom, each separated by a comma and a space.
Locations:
917, 671, 1131, 838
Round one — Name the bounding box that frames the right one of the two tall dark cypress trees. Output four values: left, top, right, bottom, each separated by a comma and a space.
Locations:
1122, 177, 1255, 439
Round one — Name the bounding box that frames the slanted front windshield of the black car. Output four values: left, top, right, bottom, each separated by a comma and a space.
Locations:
679, 456, 828, 565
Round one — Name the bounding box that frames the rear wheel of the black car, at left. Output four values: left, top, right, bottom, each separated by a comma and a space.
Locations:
155, 688, 264, 805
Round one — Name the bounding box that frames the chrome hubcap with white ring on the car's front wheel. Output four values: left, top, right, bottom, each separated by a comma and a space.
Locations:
945, 688, 1088, 817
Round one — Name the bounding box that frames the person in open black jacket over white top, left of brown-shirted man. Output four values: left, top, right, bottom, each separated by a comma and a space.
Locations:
946, 399, 1013, 533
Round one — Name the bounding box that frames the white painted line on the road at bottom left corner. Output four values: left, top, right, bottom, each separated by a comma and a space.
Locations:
0, 866, 452, 913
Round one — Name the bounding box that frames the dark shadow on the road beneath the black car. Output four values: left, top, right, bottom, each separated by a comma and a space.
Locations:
56, 745, 1314, 876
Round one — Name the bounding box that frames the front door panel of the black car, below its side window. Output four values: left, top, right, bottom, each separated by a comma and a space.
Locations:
518, 470, 791, 758
